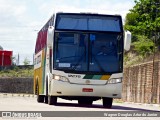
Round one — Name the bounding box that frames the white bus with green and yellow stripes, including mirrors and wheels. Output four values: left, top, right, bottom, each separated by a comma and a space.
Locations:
34, 12, 131, 108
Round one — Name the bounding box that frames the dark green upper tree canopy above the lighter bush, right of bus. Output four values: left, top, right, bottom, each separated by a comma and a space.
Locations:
125, 0, 160, 43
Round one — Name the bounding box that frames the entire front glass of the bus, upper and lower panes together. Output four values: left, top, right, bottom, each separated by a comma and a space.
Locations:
54, 13, 123, 74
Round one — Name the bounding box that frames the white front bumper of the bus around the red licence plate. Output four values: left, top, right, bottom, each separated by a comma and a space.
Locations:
49, 80, 122, 98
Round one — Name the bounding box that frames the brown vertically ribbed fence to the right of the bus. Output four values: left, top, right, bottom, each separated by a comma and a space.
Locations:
122, 61, 160, 104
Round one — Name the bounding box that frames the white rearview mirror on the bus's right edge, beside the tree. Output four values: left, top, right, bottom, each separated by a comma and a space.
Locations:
124, 31, 131, 51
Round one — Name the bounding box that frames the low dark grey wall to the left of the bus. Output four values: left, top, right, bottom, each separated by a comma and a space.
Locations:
0, 77, 33, 94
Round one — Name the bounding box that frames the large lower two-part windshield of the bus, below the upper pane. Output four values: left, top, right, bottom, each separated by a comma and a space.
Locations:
54, 32, 122, 73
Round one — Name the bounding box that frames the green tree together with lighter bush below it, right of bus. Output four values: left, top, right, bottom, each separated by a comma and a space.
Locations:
124, 0, 160, 57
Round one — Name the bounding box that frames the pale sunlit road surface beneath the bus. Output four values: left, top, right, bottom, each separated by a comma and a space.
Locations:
0, 94, 160, 120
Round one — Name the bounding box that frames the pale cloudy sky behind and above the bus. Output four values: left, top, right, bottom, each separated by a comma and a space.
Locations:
0, 0, 135, 65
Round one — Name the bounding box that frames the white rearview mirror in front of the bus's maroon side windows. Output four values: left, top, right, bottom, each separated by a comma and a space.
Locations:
47, 26, 54, 48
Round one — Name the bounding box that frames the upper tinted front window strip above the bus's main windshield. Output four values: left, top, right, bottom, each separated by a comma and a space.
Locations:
56, 15, 121, 32
